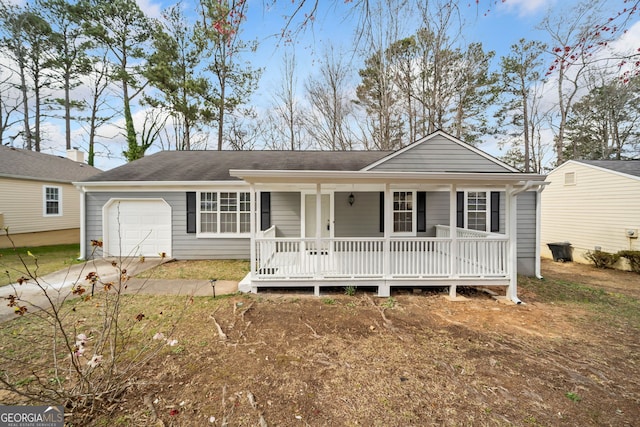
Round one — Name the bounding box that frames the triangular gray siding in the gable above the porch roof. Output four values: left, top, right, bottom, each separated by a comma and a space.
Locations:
372, 136, 510, 172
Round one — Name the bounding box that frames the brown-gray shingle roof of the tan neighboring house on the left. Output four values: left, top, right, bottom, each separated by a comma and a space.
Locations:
0, 145, 102, 183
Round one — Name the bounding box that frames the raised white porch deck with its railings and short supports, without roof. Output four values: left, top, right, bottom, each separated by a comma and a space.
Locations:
242, 225, 510, 297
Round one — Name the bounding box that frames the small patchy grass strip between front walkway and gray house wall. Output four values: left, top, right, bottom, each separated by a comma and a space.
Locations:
136, 260, 249, 282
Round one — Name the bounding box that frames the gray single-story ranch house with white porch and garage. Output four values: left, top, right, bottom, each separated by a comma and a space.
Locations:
76, 131, 545, 302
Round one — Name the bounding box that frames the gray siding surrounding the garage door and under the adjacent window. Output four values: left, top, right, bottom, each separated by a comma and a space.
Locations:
86, 192, 250, 259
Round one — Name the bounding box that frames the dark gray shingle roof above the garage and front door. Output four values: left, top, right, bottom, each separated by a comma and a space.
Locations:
87, 150, 392, 182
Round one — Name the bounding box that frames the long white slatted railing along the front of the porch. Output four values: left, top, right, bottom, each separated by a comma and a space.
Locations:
255, 235, 509, 280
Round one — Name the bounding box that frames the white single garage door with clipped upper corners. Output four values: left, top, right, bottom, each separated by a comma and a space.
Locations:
104, 199, 171, 257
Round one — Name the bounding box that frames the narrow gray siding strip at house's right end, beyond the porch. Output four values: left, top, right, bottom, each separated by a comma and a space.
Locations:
517, 191, 536, 276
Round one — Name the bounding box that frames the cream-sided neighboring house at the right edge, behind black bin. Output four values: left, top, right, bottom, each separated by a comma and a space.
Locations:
541, 160, 640, 263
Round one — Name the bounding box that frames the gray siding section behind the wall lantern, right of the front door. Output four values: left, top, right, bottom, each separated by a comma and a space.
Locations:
334, 191, 384, 237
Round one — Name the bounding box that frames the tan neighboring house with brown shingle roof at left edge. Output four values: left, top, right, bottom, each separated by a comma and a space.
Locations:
0, 145, 101, 248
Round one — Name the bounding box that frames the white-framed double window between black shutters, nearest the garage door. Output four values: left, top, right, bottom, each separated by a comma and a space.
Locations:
198, 191, 251, 235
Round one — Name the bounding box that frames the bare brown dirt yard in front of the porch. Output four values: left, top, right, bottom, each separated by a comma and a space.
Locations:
67, 261, 640, 426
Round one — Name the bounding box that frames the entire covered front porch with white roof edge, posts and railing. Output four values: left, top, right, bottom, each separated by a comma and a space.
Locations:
232, 166, 540, 303
